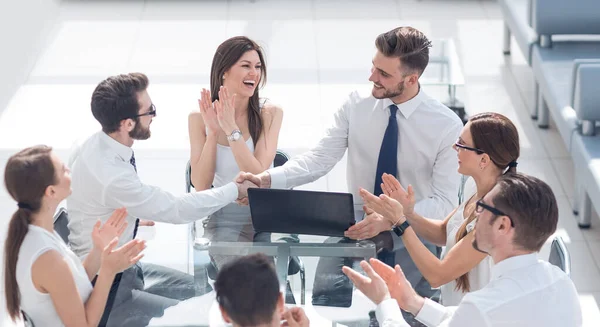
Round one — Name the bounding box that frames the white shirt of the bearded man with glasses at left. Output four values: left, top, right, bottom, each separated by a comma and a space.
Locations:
67, 132, 238, 257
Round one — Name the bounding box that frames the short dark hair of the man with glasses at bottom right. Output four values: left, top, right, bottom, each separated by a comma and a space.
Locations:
492, 173, 558, 252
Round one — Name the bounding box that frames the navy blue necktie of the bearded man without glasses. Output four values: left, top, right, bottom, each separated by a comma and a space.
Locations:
373, 104, 398, 267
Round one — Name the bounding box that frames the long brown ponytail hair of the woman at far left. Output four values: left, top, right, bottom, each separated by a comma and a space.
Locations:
4, 145, 57, 321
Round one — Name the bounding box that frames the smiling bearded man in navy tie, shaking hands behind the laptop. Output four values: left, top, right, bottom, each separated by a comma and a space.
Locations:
239, 27, 463, 322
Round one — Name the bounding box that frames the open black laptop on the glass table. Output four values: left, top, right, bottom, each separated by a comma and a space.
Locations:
248, 188, 355, 236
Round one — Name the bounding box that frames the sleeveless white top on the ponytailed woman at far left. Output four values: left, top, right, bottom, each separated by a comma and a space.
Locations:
17, 225, 92, 326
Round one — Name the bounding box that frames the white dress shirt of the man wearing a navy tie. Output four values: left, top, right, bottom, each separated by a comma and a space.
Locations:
269, 90, 463, 243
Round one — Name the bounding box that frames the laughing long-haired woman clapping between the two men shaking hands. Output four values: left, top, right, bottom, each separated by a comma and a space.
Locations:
189, 36, 283, 266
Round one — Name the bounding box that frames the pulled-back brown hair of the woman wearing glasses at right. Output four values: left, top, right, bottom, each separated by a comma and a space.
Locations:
456, 112, 521, 292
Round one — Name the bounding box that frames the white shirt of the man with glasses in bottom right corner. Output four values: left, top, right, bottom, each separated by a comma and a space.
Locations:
376, 253, 582, 327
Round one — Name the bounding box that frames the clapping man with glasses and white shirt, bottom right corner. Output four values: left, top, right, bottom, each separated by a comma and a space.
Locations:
343, 174, 582, 327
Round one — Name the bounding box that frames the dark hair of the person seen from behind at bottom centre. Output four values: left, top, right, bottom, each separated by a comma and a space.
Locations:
214, 254, 280, 326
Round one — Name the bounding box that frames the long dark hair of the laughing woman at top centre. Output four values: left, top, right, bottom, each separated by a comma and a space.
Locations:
210, 36, 267, 145
